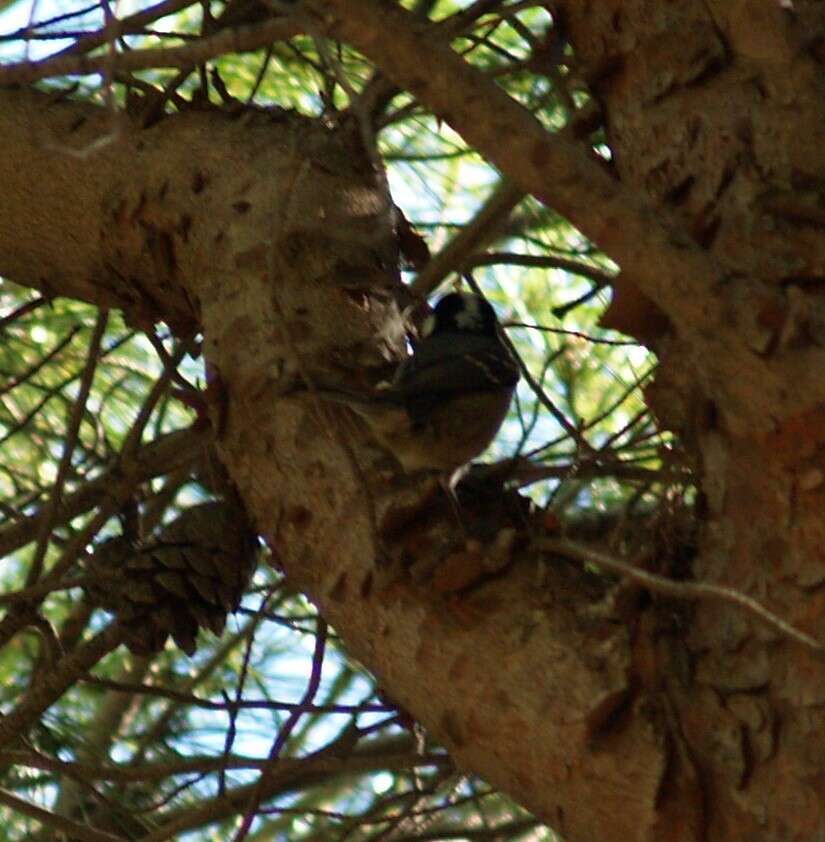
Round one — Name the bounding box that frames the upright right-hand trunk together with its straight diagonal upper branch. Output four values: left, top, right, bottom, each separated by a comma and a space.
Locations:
294, 0, 825, 839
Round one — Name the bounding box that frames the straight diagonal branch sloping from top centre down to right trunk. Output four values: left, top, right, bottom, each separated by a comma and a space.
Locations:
298, 0, 825, 431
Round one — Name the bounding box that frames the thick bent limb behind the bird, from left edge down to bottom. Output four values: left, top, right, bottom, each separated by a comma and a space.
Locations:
0, 91, 666, 839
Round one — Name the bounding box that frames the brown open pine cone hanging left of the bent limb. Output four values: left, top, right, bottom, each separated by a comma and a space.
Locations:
86, 502, 256, 655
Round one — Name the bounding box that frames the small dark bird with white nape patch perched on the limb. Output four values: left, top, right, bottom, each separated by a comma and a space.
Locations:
318, 292, 519, 485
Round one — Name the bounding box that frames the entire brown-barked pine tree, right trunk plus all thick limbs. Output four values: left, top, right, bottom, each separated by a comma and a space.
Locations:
0, 0, 825, 842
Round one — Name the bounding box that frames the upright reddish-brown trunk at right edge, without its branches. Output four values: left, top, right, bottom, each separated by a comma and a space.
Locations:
561, 0, 825, 840
